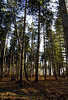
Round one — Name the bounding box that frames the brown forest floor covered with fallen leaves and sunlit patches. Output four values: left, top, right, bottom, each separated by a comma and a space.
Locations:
0, 77, 68, 100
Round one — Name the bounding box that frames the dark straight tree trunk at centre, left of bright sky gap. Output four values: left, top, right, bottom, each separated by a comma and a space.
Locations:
35, 2, 40, 82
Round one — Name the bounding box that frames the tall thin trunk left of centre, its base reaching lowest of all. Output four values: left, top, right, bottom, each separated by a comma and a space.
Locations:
20, 0, 27, 87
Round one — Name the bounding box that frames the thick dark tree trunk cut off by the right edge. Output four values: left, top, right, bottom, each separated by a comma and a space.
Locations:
59, 0, 68, 79
